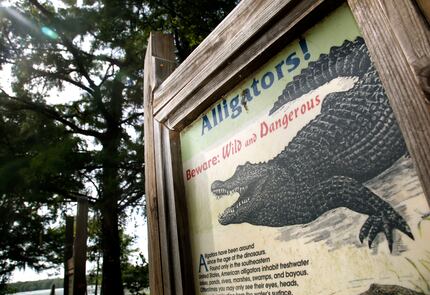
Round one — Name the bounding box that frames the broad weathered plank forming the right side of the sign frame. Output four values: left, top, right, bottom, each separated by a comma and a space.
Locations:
348, 0, 430, 202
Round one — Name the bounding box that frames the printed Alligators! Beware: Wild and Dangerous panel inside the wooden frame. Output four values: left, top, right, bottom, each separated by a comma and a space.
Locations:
181, 5, 430, 295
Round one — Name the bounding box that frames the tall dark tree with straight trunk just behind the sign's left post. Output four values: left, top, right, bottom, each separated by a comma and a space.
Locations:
0, 0, 237, 295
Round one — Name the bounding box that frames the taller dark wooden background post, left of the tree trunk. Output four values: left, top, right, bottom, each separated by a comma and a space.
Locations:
73, 199, 88, 295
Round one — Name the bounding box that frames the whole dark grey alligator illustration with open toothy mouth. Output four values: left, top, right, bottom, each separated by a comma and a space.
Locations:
211, 37, 414, 252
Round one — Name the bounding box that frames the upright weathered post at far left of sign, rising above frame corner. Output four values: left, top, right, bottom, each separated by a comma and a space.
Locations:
144, 33, 175, 294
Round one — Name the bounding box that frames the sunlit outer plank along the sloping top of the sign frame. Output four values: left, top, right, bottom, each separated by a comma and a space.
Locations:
154, 0, 299, 114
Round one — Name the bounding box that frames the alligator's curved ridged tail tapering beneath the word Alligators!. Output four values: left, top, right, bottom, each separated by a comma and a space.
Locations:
269, 37, 372, 115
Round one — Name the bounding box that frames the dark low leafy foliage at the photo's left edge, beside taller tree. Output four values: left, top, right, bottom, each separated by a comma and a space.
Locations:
0, 106, 80, 294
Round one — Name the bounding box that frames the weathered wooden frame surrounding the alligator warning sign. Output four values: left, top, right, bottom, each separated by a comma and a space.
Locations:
144, 0, 430, 294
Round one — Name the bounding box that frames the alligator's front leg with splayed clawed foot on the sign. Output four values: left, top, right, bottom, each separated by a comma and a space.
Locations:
313, 176, 414, 252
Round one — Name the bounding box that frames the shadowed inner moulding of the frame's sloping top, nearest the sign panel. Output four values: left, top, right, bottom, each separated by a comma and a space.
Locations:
156, 0, 340, 129
